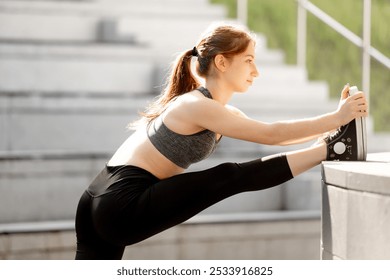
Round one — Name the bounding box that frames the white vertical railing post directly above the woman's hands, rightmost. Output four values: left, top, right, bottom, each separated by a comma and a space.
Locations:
362, 0, 371, 104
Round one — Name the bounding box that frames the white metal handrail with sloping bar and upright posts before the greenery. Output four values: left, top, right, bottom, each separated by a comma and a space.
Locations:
237, 0, 390, 104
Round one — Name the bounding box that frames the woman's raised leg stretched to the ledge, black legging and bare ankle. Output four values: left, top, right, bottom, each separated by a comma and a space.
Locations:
120, 144, 326, 245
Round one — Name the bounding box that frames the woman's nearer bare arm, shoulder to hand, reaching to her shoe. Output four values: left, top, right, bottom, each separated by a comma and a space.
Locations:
180, 93, 367, 145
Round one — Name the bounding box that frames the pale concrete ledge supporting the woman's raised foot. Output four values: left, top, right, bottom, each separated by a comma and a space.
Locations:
322, 153, 390, 259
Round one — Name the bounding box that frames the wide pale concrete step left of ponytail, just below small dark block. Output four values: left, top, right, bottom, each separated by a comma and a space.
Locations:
0, 48, 156, 93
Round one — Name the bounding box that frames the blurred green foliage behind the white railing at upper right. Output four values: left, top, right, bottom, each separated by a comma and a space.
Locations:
211, 0, 390, 131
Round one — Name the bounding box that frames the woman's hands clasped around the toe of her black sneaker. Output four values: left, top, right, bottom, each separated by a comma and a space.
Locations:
337, 84, 368, 125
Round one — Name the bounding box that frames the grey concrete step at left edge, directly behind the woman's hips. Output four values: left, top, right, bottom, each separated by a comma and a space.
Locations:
0, 158, 104, 223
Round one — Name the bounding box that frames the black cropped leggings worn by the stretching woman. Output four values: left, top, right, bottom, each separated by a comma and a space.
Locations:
76, 155, 293, 259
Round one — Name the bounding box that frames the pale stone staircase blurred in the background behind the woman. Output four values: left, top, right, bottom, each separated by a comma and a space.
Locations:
0, 0, 384, 226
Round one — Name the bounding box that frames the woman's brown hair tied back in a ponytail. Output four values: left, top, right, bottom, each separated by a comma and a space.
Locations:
130, 25, 255, 126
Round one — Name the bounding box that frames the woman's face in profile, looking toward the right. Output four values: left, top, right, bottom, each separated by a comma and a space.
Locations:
224, 42, 259, 92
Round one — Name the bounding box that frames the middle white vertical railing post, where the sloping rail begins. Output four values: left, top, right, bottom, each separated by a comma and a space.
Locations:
297, 0, 307, 67
